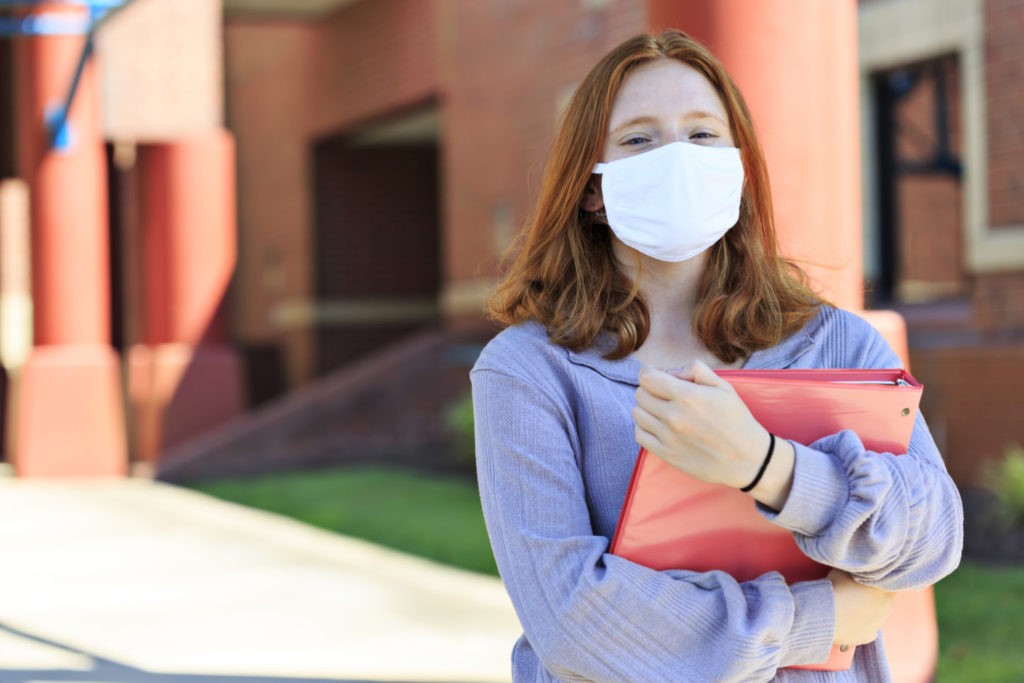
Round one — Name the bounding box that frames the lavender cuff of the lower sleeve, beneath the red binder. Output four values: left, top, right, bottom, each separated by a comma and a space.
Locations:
779, 579, 836, 667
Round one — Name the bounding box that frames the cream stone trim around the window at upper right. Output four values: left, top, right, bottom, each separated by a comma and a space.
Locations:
857, 0, 1024, 273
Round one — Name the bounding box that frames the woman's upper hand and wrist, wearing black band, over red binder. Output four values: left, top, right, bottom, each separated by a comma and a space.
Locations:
633, 361, 796, 510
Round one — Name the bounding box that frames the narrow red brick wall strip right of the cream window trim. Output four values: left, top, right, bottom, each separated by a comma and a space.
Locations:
985, 0, 1024, 227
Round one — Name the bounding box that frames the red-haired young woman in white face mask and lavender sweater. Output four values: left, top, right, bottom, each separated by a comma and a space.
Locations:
472, 32, 963, 682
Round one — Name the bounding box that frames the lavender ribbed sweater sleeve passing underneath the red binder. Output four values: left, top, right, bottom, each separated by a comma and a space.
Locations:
472, 369, 835, 681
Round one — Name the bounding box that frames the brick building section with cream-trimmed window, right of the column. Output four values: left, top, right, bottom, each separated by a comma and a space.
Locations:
858, 0, 1024, 483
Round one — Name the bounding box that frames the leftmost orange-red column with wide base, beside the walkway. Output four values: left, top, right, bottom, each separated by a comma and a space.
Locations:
13, 4, 127, 476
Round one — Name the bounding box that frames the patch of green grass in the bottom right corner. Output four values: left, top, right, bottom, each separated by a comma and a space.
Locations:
935, 563, 1024, 683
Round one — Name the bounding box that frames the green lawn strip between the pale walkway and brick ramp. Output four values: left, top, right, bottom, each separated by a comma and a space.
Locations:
193, 467, 498, 575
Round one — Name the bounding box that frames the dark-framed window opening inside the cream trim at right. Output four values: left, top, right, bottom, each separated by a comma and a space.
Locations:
867, 55, 967, 306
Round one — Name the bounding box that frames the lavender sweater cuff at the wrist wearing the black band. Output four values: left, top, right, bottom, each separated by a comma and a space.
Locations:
758, 441, 850, 537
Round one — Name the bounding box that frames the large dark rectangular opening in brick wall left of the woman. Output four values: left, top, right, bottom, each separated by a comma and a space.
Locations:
313, 136, 440, 375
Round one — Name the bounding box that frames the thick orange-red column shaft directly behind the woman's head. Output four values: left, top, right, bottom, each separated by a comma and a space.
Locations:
647, 0, 863, 309
